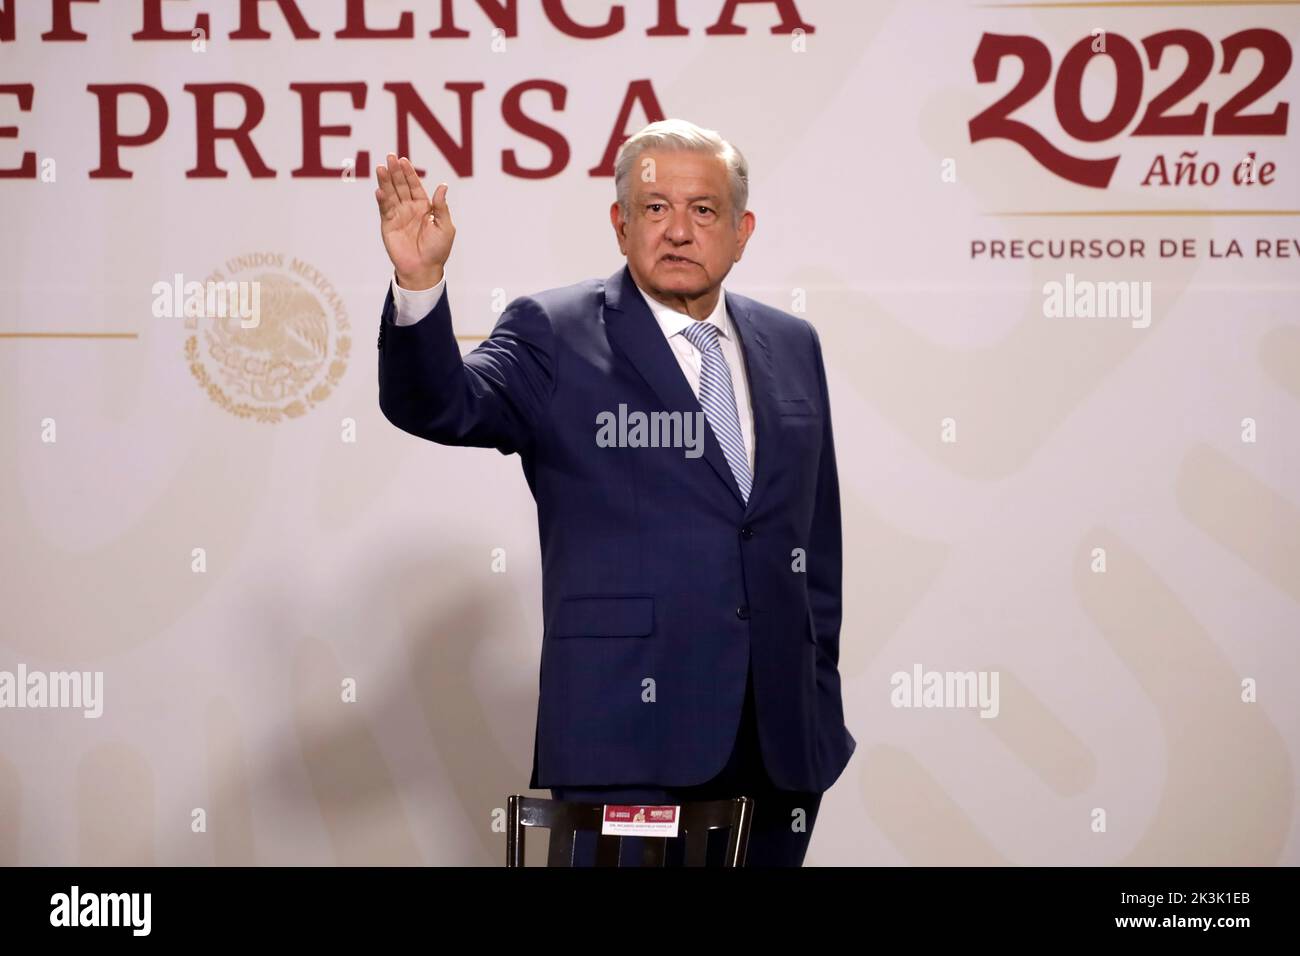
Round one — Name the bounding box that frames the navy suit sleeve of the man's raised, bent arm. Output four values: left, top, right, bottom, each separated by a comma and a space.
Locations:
378, 280, 555, 455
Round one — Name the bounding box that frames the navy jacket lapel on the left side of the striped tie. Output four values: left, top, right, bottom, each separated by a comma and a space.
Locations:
605, 265, 754, 505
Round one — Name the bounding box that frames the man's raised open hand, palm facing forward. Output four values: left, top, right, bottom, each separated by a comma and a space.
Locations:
374, 152, 456, 289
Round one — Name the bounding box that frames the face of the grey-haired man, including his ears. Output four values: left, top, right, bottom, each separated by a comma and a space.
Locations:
610, 150, 754, 308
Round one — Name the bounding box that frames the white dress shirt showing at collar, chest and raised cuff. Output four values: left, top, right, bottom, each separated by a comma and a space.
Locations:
391, 273, 754, 475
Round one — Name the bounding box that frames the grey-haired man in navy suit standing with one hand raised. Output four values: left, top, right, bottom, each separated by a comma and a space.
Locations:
374, 120, 857, 866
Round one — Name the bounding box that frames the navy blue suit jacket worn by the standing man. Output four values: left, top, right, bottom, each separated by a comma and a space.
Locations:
378, 265, 857, 791
